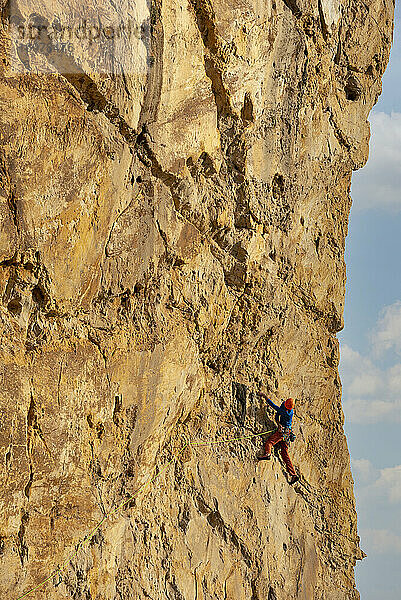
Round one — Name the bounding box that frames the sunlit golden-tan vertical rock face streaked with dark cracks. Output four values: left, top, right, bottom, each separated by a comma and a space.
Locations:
0, 0, 394, 600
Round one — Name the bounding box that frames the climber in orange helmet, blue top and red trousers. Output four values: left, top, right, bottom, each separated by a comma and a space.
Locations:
258, 392, 299, 485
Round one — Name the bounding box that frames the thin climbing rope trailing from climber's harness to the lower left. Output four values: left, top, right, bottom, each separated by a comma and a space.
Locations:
16, 429, 274, 600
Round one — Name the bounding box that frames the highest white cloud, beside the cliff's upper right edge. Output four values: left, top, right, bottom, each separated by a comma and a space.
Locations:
352, 111, 401, 211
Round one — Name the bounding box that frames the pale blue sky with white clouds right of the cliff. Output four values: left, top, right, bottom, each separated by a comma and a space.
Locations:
339, 6, 401, 600
